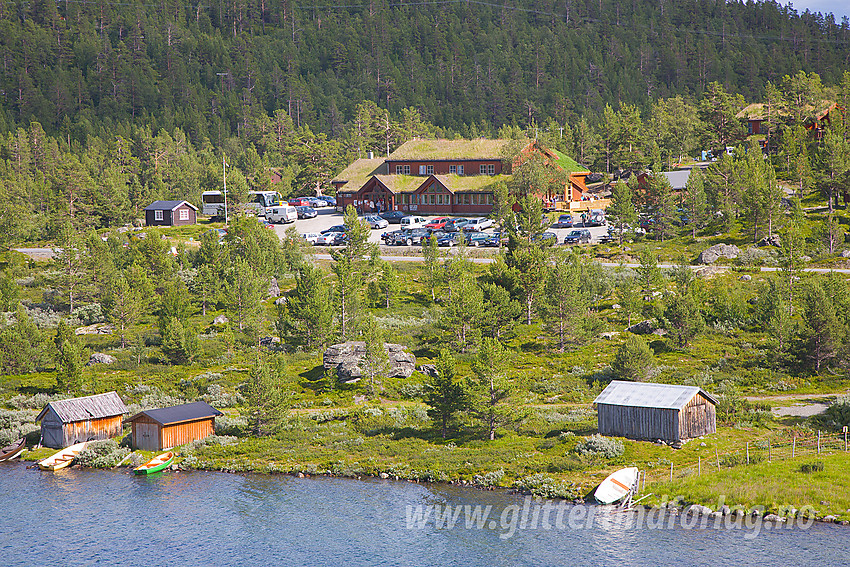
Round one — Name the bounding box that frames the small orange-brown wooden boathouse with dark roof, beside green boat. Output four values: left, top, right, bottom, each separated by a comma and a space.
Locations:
128, 402, 223, 451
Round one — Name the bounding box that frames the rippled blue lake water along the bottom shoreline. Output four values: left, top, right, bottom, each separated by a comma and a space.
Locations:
0, 463, 850, 567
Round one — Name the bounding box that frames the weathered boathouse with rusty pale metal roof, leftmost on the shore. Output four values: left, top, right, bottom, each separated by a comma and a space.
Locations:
35, 392, 127, 449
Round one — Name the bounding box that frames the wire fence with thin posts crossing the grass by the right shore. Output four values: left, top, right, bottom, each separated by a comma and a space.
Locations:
641, 431, 848, 489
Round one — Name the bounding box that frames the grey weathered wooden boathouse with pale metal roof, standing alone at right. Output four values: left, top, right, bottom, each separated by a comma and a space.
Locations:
594, 380, 717, 443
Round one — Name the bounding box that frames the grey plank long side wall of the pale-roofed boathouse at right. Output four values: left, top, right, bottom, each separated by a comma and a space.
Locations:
597, 404, 679, 441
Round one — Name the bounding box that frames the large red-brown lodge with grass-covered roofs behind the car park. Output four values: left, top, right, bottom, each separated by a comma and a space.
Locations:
331, 139, 590, 215
